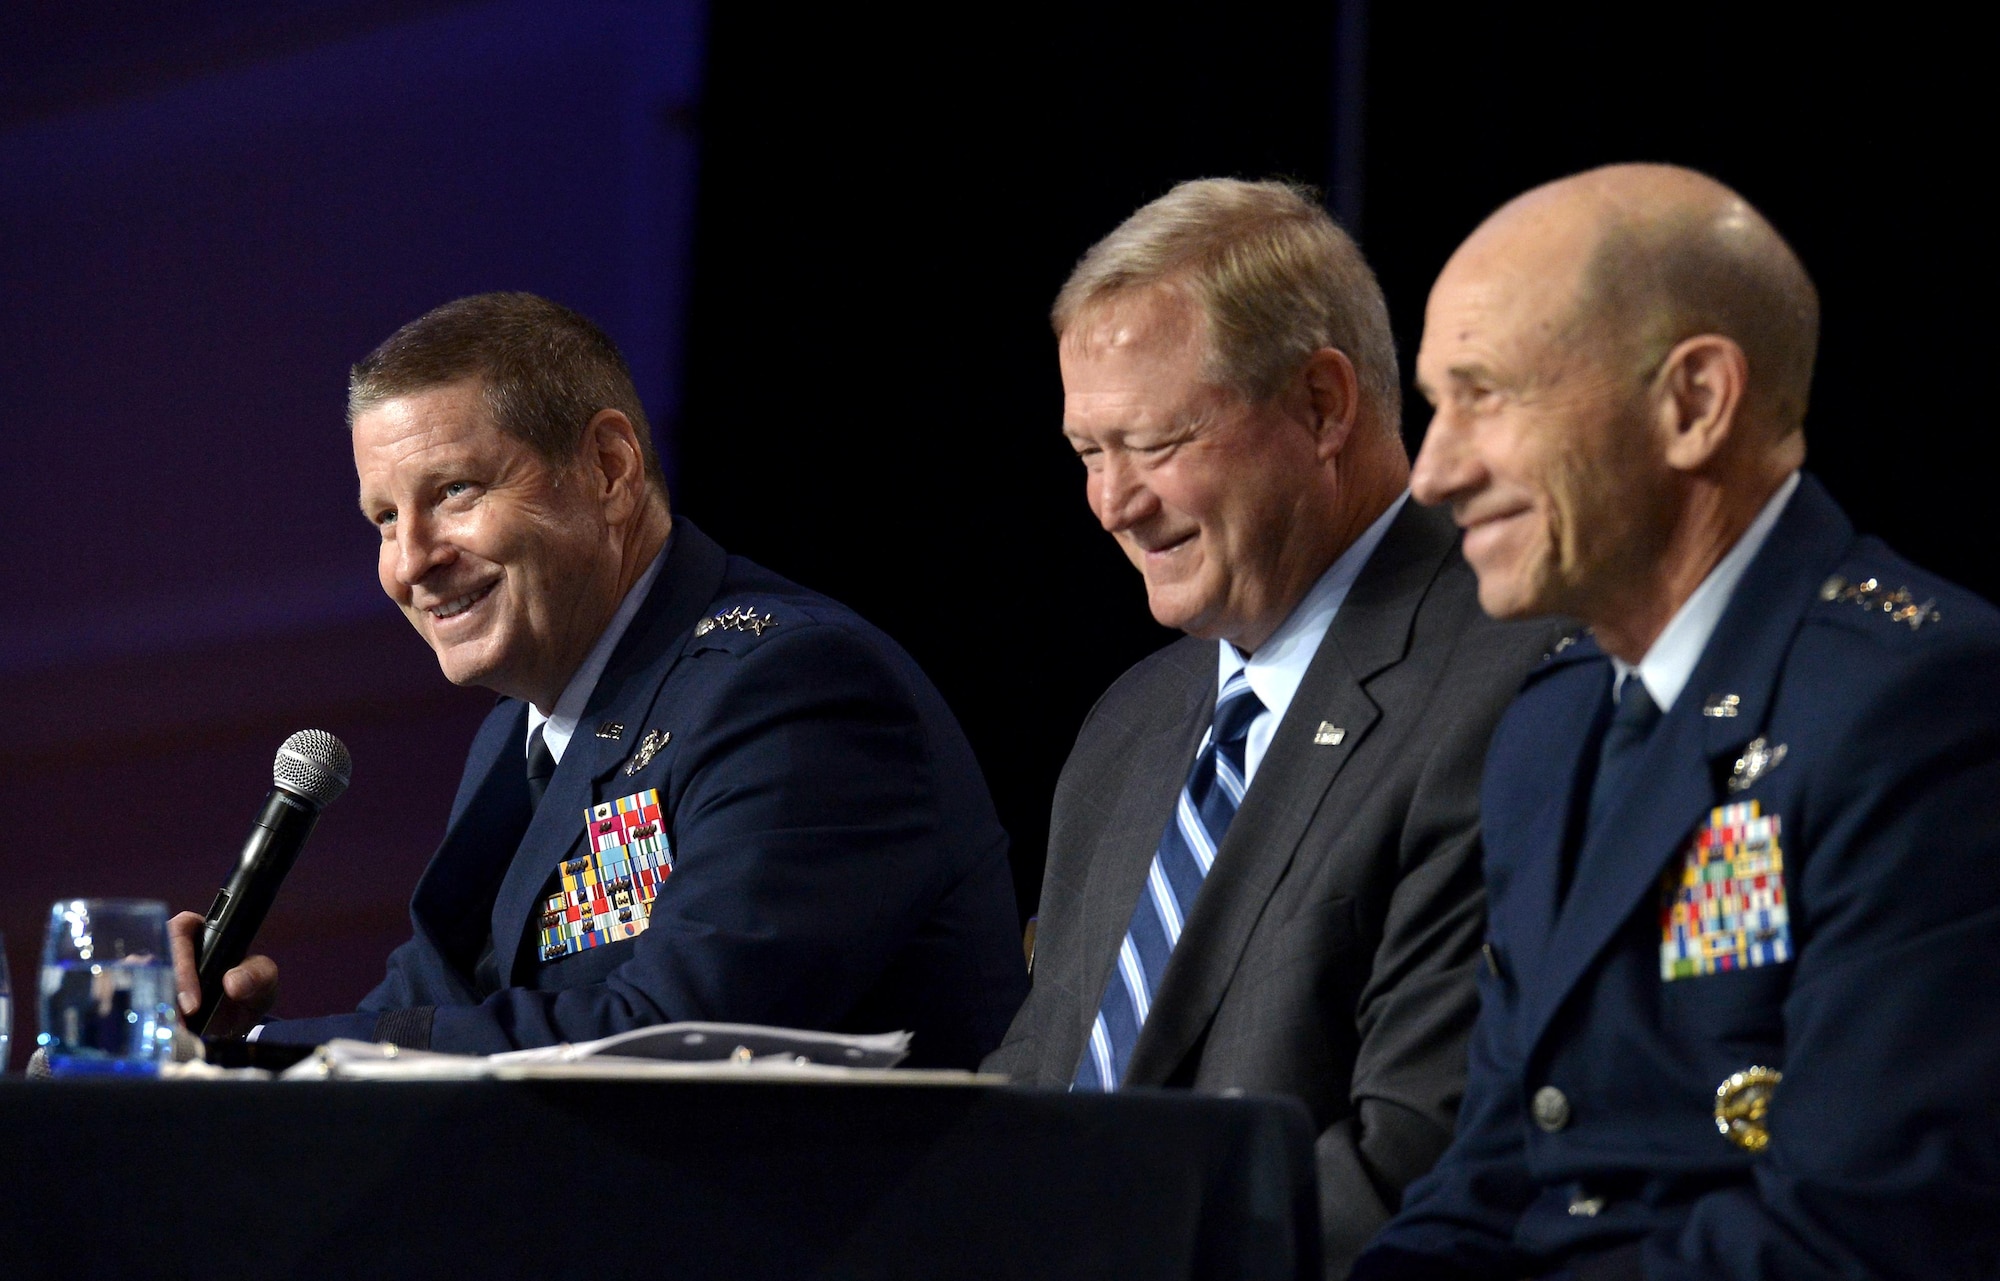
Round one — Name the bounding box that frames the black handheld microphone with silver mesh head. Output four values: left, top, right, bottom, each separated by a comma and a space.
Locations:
188, 729, 354, 1035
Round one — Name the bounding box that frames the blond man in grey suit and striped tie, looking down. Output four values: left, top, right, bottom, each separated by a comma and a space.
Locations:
986, 182, 1554, 1275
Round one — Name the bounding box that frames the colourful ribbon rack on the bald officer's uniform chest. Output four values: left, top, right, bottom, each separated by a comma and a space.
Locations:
1660, 801, 1792, 981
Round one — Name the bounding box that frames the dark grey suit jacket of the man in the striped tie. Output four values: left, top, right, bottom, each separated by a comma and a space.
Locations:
986, 502, 1556, 1273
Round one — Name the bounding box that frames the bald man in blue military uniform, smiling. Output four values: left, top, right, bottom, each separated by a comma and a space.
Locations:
1356, 166, 2000, 1281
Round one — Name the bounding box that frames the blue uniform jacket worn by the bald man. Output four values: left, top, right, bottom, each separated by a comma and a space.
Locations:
1358, 476, 2000, 1281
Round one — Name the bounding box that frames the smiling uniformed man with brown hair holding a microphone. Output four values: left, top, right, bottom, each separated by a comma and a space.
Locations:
176, 294, 1026, 1067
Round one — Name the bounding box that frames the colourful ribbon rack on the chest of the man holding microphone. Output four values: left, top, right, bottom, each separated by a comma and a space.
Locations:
542, 787, 674, 961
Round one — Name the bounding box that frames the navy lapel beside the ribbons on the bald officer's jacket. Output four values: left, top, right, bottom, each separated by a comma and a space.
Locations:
1522, 476, 1854, 1053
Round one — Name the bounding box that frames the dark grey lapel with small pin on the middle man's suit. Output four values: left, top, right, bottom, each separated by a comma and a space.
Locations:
1124, 502, 1454, 1085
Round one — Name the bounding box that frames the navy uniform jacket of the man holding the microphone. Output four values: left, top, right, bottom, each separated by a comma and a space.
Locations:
264, 518, 1026, 1067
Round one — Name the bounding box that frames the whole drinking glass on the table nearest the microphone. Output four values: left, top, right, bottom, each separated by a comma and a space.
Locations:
40, 899, 174, 1077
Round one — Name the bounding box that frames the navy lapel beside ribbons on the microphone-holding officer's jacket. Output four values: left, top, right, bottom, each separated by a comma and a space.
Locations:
492, 516, 728, 987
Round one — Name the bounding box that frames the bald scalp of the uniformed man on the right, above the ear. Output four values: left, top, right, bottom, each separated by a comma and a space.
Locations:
1472, 164, 1820, 436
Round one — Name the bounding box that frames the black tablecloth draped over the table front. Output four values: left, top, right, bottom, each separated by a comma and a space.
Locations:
0, 1081, 1320, 1281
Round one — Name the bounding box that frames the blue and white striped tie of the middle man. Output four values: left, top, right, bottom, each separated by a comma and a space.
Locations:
1070, 671, 1264, 1091
